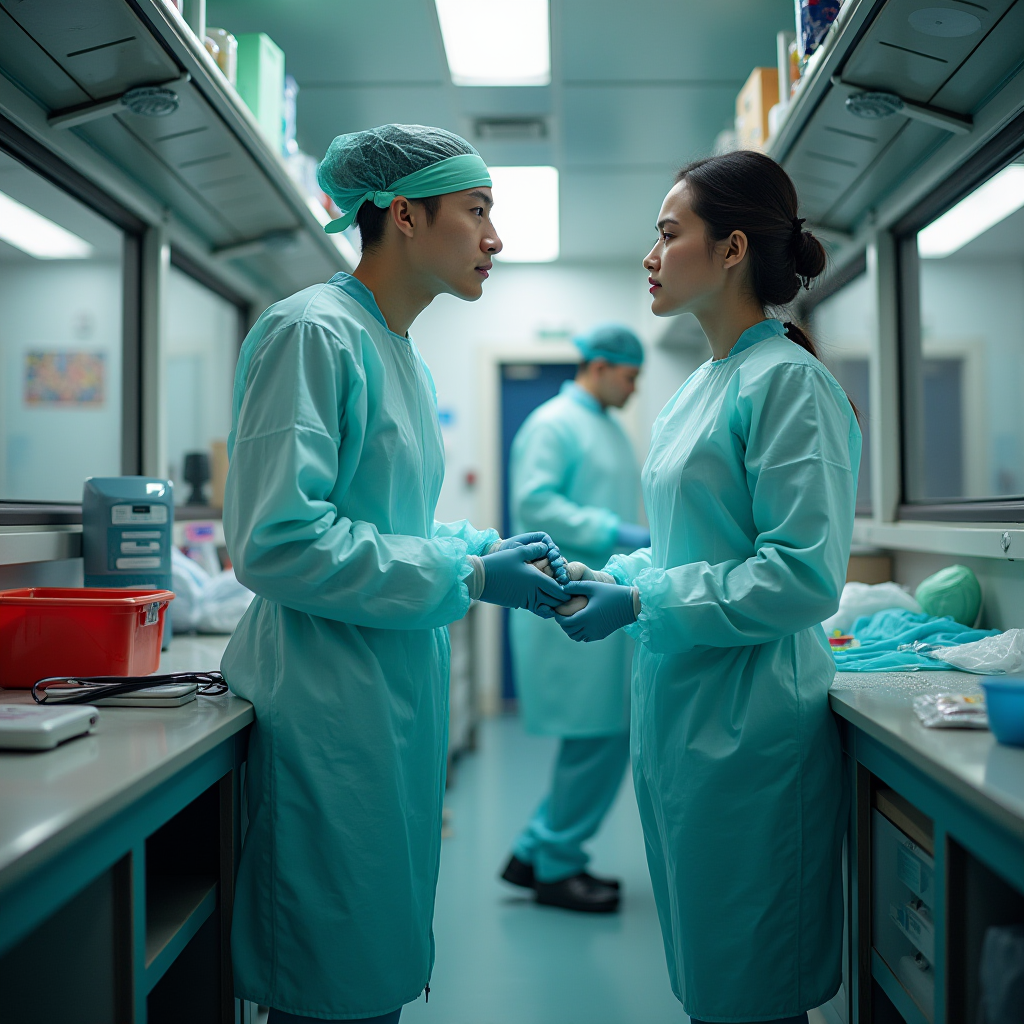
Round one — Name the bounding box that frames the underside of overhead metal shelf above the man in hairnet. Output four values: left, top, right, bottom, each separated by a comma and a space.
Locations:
0, 0, 348, 296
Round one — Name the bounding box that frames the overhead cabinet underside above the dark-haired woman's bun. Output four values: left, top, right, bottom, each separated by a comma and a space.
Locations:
769, 0, 1024, 231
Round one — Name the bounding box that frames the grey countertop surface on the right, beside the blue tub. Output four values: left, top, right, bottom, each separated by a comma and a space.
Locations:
829, 672, 1024, 841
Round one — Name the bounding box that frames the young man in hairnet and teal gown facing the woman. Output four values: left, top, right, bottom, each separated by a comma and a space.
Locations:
223, 125, 565, 1024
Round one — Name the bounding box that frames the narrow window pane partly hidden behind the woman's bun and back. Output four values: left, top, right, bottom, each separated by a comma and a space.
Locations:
813, 273, 878, 515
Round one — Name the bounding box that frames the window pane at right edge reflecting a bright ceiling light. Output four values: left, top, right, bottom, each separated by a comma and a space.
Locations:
903, 158, 1024, 504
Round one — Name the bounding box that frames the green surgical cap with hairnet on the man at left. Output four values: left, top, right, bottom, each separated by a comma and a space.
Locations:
316, 125, 490, 234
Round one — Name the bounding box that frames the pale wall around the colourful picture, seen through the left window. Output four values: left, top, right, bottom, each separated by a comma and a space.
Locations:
0, 261, 122, 502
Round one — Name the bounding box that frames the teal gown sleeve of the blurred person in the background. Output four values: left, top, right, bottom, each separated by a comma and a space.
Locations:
511, 423, 620, 552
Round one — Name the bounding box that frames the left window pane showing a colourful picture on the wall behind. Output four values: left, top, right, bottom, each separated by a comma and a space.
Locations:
0, 153, 124, 503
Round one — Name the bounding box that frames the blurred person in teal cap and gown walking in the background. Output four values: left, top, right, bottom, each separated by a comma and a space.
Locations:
502, 324, 650, 912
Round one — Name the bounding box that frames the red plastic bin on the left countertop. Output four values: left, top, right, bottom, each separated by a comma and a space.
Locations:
0, 587, 174, 689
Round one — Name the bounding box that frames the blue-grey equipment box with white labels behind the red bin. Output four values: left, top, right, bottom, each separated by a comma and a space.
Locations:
82, 476, 174, 590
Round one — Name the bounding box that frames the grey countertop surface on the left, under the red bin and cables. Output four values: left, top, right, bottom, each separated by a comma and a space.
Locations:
0, 636, 247, 892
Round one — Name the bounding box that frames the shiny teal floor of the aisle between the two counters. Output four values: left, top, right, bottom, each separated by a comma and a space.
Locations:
401, 718, 687, 1024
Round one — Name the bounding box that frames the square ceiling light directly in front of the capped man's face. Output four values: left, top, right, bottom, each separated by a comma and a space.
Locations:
488, 167, 558, 263
